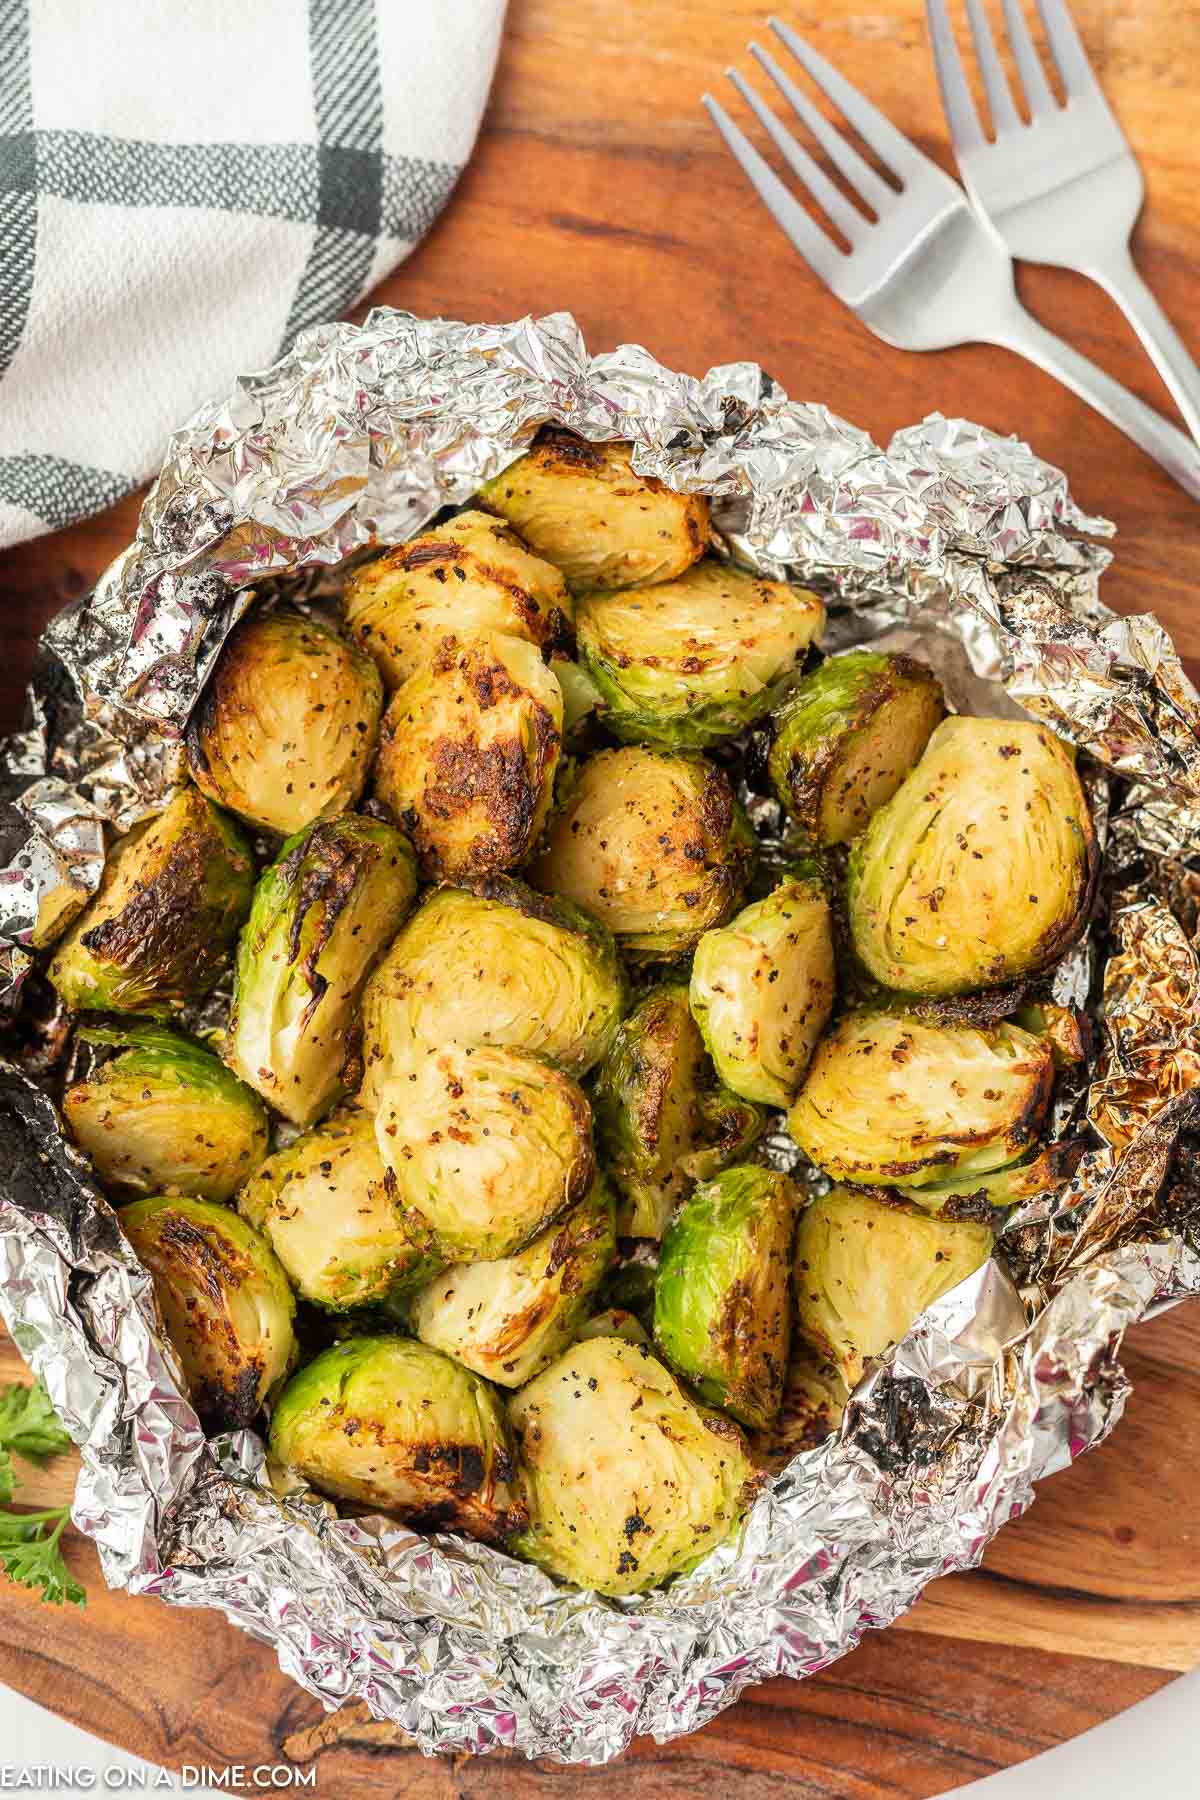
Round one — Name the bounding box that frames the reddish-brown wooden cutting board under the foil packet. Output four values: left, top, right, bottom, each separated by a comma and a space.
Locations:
0, 0, 1200, 1800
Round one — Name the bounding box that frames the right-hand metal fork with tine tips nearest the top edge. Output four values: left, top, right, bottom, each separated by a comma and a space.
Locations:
925, 0, 1200, 439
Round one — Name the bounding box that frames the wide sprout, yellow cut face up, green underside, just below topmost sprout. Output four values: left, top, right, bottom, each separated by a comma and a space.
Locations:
576, 560, 826, 751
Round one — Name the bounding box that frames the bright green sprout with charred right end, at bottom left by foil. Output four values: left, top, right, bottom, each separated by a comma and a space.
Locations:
272, 1336, 529, 1543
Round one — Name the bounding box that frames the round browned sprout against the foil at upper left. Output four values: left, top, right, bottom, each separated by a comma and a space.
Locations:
187, 610, 383, 837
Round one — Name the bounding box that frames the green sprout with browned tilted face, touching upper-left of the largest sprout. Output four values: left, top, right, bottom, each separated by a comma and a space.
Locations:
766, 650, 946, 844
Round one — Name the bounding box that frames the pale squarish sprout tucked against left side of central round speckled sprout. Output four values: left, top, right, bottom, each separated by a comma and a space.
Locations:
237, 1111, 441, 1312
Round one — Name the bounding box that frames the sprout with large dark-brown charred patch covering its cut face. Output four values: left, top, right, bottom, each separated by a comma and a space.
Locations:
374, 634, 563, 880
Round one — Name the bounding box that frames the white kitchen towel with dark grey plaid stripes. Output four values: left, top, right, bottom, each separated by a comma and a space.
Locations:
0, 0, 504, 545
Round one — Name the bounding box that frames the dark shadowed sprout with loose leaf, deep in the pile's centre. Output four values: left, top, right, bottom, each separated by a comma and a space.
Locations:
592, 981, 765, 1238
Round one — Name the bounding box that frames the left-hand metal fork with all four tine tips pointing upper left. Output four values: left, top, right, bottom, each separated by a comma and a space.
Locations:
703, 20, 1200, 499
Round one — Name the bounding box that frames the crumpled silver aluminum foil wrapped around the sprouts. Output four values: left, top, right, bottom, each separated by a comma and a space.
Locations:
0, 311, 1200, 1762
